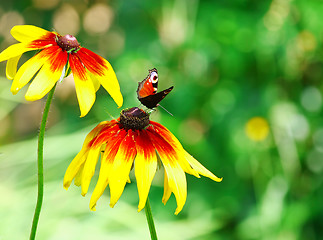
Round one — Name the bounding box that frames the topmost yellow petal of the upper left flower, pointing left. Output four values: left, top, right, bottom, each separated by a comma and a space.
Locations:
10, 25, 48, 42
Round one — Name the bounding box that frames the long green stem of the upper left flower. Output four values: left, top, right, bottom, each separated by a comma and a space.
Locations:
30, 84, 56, 240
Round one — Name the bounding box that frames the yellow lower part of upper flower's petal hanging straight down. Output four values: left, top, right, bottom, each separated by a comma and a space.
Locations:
73, 72, 95, 117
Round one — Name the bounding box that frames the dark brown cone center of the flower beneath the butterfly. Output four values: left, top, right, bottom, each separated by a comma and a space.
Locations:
120, 107, 149, 130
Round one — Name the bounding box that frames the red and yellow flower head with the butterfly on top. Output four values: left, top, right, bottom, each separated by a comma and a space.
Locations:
64, 108, 222, 214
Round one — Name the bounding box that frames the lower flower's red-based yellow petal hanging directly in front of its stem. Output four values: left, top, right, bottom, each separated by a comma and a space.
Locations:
135, 131, 157, 212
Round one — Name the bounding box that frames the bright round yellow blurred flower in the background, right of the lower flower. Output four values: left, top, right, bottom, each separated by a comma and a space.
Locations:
245, 117, 269, 142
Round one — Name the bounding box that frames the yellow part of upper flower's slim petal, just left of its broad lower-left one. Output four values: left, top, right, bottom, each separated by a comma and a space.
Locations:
10, 54, 47, 94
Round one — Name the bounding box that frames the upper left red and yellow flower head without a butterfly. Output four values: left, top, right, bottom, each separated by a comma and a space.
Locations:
0, 25, 123, 117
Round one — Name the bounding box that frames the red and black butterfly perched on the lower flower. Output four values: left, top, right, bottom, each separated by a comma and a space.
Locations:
137, 68, 174, 109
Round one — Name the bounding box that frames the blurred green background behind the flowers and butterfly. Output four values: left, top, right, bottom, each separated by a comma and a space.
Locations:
0, 0, 323, 240
